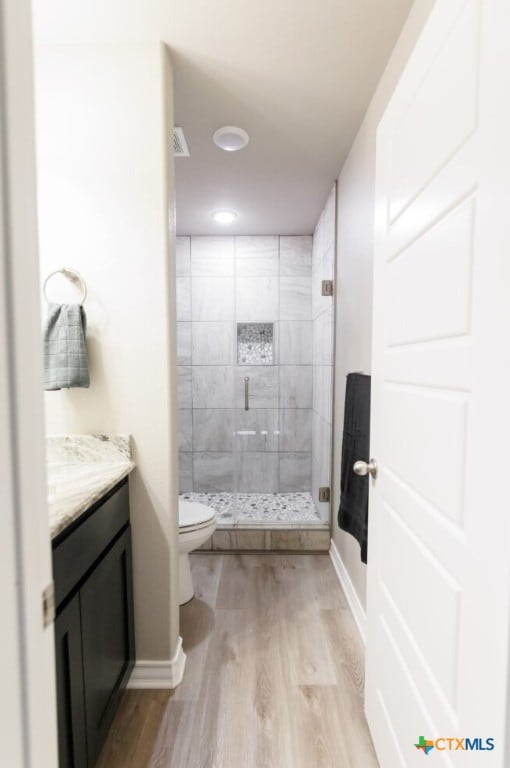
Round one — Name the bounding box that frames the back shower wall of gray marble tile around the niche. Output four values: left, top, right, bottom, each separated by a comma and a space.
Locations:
177, 235, 313, 493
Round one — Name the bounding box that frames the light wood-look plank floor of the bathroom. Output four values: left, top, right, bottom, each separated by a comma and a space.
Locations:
97, 554, 378, 768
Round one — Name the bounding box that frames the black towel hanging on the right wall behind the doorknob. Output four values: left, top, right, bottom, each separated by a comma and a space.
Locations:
338, 373, 370, 563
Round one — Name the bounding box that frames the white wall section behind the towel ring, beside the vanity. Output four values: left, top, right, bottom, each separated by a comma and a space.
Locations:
36, 43, 178, 660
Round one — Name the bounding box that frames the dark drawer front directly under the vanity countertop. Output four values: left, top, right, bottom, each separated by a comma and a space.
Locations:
53, 480, 129, 608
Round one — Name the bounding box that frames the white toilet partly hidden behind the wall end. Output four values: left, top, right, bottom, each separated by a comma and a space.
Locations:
179, 499, 216, 605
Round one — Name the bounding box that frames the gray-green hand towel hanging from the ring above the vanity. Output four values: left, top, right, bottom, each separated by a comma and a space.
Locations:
44, 304, 90, 390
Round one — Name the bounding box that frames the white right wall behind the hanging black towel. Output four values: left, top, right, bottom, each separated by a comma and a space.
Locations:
333, 0, 434, 606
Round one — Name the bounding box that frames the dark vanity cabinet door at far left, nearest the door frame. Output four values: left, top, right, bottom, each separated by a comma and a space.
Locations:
55, 595, 88, 768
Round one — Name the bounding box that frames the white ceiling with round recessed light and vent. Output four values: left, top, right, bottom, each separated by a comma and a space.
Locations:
33, 0, 412, 234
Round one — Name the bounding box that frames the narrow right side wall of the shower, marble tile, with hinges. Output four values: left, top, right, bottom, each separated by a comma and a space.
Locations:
311, 185, 336, 522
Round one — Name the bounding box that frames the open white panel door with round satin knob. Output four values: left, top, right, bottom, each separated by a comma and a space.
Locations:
366, 0, 510, 768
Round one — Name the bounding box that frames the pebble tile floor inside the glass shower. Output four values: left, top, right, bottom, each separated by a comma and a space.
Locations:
181, 492, 321, 525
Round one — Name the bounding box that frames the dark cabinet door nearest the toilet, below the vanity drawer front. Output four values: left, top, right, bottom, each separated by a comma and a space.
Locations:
80, 528, 134, 768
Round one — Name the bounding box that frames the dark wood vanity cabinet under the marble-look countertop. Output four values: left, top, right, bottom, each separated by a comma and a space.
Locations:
53, 480, 135, 768
